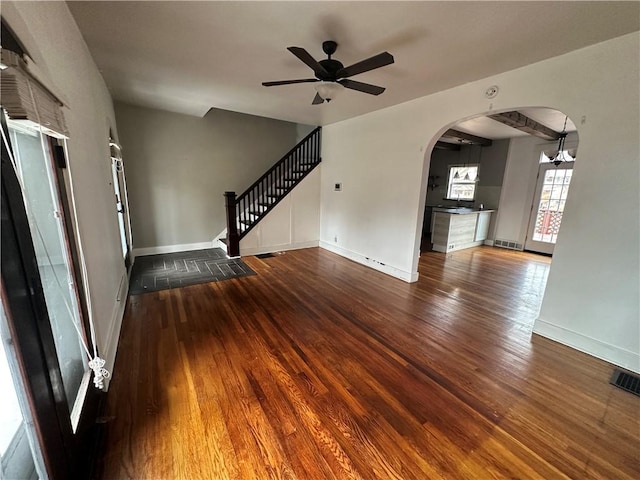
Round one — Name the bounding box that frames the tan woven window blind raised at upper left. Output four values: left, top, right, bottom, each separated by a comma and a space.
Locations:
0, 48, 68, 137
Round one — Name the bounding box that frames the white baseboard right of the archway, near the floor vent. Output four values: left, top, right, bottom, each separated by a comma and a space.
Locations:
533, 318, 640, 373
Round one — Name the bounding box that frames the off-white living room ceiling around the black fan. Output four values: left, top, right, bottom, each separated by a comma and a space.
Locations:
68, 1, 640, 131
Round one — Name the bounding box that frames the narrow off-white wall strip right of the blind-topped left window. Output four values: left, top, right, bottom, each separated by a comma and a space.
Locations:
2, 1, 127, 384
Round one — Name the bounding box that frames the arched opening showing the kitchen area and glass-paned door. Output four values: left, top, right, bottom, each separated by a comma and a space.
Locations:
417, 107, 578, 326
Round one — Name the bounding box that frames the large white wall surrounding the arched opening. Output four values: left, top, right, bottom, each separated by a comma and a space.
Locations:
320, 32, 640, 371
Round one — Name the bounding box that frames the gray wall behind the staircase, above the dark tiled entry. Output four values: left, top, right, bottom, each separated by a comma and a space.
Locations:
115, 102, 299, 248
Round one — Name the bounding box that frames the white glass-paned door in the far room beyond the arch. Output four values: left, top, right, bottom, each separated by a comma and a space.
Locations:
525, 162, 573, 255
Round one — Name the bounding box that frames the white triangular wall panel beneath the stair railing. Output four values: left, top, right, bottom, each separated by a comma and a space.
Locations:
240, 169, 322, 255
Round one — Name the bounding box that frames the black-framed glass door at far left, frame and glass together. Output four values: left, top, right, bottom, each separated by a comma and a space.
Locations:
0, 120, 101, 480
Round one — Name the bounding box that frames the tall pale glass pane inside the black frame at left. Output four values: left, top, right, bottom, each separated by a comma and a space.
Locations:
9, 123, 87, 411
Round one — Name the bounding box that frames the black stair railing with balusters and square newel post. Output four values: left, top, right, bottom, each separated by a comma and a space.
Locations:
224, 127, 321, 257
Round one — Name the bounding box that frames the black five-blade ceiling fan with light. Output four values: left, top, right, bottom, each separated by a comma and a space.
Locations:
262, 40, 393, 105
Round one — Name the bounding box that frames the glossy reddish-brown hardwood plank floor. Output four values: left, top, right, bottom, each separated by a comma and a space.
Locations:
100, 247, 640, 480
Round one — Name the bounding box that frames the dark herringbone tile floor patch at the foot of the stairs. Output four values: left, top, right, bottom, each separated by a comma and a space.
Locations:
129, 248, 256, 295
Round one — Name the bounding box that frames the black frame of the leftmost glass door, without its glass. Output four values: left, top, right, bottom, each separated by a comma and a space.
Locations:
0, 113, 105, 480
